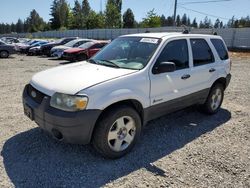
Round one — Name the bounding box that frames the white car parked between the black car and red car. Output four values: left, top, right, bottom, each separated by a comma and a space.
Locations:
50, 39, 92, 58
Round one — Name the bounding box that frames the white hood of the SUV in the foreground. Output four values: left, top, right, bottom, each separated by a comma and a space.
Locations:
30, 61, 138, 96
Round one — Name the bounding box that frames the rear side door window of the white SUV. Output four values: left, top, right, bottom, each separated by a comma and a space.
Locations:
190, 39, 214, 66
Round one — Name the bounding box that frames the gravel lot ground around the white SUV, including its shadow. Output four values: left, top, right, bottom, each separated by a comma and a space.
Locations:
0, 53, 250, 188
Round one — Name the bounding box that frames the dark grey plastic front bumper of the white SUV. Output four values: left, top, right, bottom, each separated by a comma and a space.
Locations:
23, 85, 101, 144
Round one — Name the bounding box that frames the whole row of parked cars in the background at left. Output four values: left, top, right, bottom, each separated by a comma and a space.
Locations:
0, 37, 110, 61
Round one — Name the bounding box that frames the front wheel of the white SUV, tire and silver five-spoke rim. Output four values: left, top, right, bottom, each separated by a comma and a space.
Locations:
92, 105, 141, 159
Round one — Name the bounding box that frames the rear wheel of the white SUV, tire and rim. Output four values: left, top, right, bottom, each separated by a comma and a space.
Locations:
201, 83, 225, 115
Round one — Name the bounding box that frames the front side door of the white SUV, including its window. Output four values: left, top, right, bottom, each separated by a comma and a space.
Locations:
150, 39, 192, 116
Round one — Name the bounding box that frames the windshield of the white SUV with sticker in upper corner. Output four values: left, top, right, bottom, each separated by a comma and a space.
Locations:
92, 37, 160, 70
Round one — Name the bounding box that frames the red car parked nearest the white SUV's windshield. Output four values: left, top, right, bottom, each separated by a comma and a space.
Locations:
62, 41, 109, 61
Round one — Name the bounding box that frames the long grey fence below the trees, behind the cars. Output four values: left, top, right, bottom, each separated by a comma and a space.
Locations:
0, 27, 250, 49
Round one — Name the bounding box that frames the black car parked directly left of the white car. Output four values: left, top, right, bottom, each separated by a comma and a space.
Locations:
41, 37, 78, 56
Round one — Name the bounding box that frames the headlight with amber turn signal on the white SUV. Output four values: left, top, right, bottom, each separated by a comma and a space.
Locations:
50, 93, 88, 112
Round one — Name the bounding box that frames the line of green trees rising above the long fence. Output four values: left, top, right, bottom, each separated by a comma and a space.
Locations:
0, 0, 250, 34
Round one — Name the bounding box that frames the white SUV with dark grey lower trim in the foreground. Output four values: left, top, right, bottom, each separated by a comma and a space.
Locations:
23, 33, 231, 158
